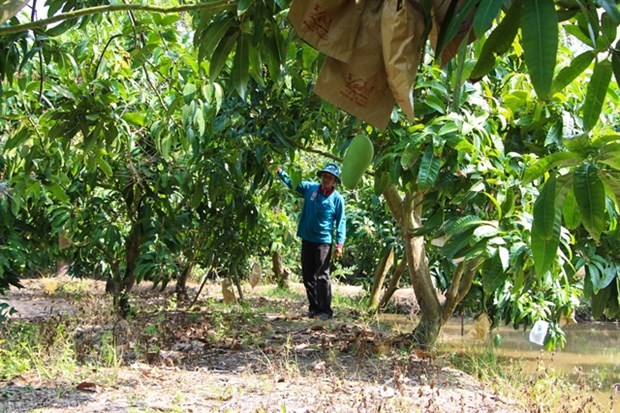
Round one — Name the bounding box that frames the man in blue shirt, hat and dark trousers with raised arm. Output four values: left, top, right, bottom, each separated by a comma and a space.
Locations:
277, 163, 346, 320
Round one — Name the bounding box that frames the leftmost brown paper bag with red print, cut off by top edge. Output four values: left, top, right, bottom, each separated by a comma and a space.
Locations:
288, 0, 365, 62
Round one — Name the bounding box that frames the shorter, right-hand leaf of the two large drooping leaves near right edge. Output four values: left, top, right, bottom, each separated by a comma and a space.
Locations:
573, 164, 605, 242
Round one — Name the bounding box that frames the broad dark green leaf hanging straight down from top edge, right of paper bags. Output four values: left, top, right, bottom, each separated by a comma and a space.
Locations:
520, 0, 558, 98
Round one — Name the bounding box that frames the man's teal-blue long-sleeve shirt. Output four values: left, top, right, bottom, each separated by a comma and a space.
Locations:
278, 170, 346, 245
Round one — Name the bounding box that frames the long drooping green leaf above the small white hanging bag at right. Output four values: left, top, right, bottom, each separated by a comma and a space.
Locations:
531, 175, 561, 276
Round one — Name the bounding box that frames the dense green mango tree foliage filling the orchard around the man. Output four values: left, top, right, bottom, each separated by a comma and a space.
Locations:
0, 0, 620, 344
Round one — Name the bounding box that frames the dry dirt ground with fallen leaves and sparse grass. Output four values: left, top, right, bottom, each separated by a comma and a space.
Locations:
0, 280, 526, 413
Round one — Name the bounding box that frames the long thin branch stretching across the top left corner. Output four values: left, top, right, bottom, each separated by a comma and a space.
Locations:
0, 0, 235, 36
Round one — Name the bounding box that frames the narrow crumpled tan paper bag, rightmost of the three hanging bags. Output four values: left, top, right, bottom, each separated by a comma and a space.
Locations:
381, 0, 425, 120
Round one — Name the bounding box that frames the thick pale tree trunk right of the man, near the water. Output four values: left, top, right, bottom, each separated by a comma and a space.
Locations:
383, 185, 442, 348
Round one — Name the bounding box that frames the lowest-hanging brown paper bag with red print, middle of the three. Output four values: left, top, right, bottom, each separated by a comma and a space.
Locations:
314, 0, 394, 129
